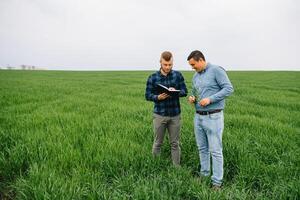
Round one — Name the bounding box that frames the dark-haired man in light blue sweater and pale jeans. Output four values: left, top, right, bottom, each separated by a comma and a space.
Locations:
187, 50, 233, 190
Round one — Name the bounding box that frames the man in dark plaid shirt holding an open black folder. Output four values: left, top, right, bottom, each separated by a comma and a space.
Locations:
145, 51, 187, 165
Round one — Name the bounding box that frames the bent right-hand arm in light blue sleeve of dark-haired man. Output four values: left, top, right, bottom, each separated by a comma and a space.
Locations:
208, 67, 234, 103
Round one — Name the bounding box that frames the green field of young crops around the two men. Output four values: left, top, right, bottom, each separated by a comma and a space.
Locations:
0, 70, 300, 200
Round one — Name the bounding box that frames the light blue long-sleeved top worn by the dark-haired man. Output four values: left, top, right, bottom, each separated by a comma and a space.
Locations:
192, 63, 233, 111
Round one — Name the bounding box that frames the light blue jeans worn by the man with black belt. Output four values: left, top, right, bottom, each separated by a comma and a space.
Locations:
194, 111, 224, 186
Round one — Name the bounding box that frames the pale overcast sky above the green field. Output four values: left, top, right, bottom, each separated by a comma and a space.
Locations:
0, 0, 300, 70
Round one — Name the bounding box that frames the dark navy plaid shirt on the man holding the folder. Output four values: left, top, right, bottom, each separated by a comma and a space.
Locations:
145, 70, 187, 116
